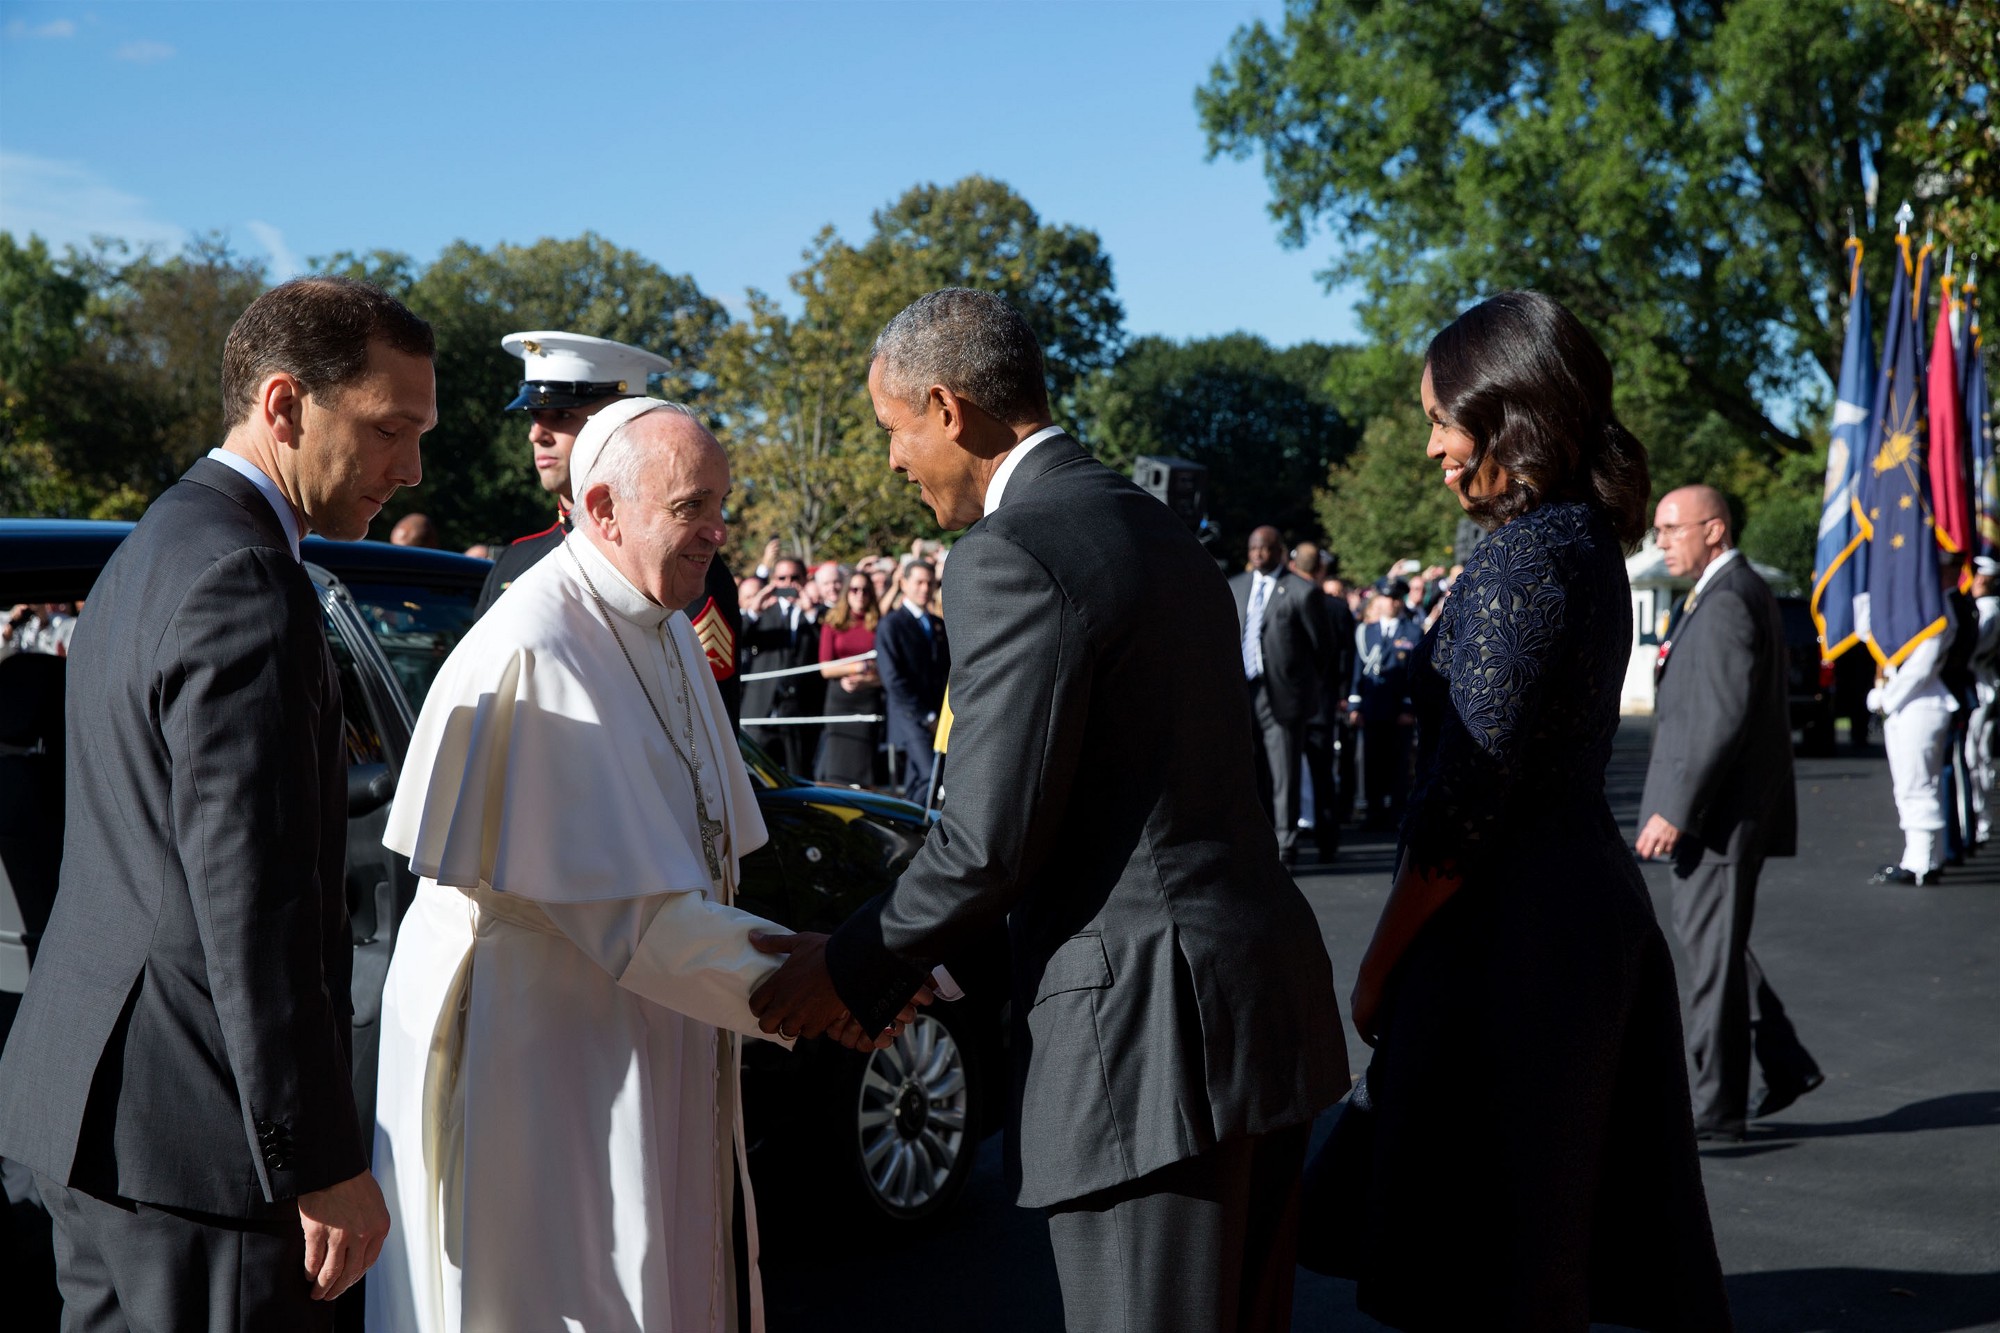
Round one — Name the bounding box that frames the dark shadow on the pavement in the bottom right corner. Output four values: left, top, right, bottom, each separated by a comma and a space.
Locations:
1724, 1269, 2000, 1333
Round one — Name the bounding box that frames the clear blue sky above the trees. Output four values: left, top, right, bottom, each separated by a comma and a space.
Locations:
0, 0, 1358, 344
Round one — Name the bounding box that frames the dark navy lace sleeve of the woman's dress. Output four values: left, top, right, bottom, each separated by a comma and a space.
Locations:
1404, 530, 1566, 873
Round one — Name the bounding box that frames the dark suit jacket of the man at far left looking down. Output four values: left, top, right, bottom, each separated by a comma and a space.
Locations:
0, 458, 368, 1225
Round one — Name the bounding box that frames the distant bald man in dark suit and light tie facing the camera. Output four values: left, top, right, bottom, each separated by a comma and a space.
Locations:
1230, 526, 1328, 865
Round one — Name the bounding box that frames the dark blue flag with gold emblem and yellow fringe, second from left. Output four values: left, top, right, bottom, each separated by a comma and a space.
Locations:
1862, 238, 1946, 667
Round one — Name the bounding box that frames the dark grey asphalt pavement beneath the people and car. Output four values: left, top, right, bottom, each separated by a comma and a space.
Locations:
760, 721, 2000, 1333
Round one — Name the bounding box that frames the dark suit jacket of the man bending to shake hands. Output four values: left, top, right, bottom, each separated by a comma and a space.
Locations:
826, 436, 1348, 1207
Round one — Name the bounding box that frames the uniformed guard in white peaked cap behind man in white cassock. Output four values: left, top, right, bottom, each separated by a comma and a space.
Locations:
478, 328, 742, 723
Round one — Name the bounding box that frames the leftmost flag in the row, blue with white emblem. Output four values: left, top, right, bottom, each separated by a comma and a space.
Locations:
1812, 238, 1876, 662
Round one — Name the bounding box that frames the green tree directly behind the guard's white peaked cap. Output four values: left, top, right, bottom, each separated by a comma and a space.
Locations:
324, 232, 728, 544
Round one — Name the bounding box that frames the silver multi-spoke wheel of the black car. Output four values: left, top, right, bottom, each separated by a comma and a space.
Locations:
846, 1005, 982, 1223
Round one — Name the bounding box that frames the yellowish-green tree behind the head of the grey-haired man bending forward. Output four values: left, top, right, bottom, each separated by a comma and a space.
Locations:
710, 176, 1124, 558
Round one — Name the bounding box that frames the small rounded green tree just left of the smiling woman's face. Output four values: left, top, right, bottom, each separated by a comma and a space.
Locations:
1314, 404, 1464, 580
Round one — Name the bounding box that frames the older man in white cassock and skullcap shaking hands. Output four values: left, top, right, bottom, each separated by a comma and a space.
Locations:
368, 398, 782, 1333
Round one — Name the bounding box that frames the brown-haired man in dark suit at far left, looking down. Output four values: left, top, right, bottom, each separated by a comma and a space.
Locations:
0, 278, 436, 1331
